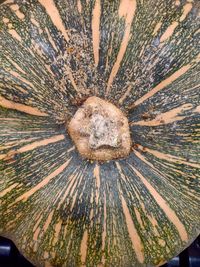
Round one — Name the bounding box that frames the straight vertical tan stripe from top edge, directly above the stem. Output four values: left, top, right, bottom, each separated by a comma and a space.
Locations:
92, 0, 101, 67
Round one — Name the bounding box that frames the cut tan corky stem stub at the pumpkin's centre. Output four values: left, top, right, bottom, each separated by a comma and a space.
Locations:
68, 96, 131, 161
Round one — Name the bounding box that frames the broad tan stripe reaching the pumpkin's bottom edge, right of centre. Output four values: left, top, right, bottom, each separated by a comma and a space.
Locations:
121, 195, 144, 263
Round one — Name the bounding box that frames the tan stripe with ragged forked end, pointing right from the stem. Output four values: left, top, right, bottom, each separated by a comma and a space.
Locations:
130, 103, 193, 126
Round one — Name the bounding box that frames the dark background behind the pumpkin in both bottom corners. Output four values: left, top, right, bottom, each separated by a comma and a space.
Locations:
0, 236, 200, 267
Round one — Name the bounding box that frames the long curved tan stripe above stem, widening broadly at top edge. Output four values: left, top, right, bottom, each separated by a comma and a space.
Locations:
106, 0, 136, 94
